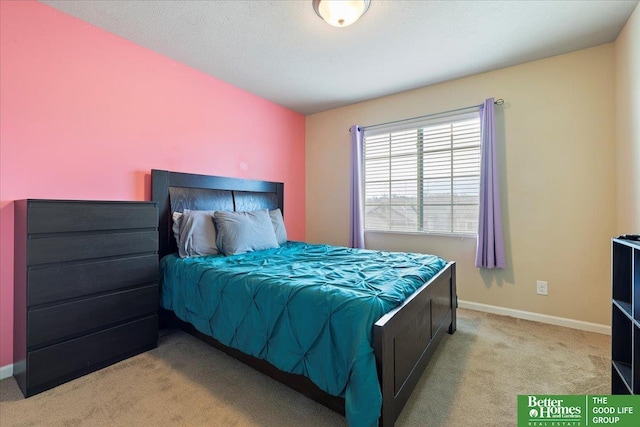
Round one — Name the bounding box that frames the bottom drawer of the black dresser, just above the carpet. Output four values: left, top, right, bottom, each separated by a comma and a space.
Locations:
27, 315, 158, 389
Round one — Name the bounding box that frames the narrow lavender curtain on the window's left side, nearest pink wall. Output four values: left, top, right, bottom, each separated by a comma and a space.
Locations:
349, 125, 364, 248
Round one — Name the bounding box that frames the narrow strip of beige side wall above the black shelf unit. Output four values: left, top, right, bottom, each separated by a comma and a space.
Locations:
615, 5, 640, 233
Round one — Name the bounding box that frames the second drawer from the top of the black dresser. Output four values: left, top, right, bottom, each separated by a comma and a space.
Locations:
27, 231, 158, 265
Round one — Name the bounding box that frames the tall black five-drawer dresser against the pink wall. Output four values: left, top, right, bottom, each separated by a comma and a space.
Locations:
13, 200, 159, 397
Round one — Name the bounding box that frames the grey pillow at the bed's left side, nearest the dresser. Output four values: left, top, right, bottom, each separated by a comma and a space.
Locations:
173, 209, 219, 258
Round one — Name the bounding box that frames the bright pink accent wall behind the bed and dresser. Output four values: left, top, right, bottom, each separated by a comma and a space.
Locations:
0, 1, 305, 367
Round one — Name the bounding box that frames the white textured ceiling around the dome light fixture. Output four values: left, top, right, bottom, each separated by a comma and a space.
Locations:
42, 0, 638, 114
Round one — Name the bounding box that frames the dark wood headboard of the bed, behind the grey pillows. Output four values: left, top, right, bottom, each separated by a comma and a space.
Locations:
151, 169, 284, 257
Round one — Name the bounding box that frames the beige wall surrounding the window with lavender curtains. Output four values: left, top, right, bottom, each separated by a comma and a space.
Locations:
306, 43, 616, 324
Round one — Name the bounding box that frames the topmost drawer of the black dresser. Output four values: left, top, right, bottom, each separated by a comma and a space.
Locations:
27, 201, 158, 234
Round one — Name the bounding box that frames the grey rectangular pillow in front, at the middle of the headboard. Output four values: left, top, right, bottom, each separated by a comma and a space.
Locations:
213, 209, 280, 255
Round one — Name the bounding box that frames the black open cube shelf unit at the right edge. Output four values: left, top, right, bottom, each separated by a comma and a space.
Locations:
611, 238, 640, 394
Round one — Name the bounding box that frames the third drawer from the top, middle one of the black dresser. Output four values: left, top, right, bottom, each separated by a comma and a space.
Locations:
27, 254, 158, 306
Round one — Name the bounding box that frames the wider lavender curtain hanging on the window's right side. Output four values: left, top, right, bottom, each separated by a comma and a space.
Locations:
476, 98, 505, 268
